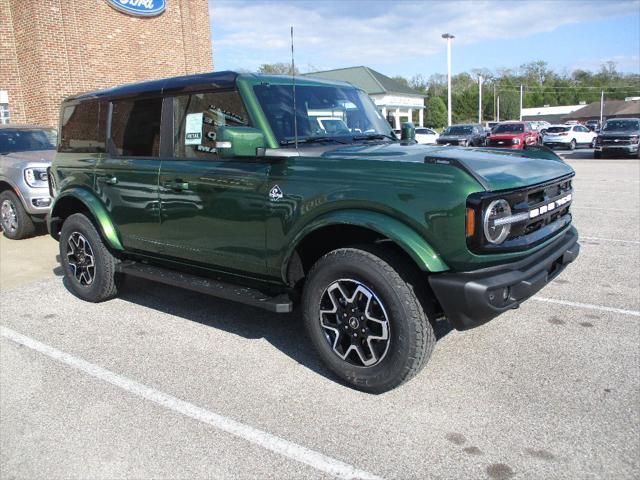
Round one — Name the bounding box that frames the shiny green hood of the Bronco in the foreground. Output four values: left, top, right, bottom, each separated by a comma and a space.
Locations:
318, 143, 574, 191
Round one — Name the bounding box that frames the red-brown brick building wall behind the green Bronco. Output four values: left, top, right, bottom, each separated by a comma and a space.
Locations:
0, 0, 213, 127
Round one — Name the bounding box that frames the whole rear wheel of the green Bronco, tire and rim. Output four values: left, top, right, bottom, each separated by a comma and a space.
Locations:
60, 213, 117, 302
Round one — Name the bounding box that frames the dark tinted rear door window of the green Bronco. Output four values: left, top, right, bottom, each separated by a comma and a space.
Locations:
111, 98, 162, 157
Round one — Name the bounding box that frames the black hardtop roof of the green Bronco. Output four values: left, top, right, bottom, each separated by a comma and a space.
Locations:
64, 71, 352, 102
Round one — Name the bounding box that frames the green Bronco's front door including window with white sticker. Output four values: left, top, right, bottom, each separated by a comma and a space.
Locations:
159, 91, 269, 276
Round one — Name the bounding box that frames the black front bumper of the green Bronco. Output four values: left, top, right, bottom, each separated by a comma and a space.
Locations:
429, 227, 580, 330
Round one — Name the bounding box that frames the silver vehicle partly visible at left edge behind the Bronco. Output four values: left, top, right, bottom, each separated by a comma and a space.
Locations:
0, 125, 57, 240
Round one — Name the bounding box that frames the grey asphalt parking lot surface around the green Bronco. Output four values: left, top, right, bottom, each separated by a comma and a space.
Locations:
0, 150, 640, 480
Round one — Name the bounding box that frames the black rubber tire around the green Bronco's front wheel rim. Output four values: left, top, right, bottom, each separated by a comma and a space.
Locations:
302, 245, 436, 393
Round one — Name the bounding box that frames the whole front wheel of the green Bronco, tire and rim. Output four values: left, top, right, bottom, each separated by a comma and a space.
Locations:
302, 247, 435, 393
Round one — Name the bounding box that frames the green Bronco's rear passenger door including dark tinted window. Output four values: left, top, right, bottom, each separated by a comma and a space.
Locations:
95, 97, 162, 253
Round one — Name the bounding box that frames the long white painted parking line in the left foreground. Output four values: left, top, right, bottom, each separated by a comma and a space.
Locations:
0, 327, 380, 479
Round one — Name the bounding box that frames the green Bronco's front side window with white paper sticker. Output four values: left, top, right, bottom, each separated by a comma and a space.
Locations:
173, 90, 249, 159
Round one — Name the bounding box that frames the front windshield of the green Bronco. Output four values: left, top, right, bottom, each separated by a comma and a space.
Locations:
254, 84, 392, 144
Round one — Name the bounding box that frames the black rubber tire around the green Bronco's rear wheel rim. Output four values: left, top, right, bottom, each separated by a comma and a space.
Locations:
60, 213, 118, 303
